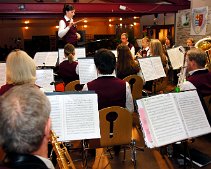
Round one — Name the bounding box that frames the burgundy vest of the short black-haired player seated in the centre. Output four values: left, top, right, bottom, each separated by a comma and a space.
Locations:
87, 76, 126, 110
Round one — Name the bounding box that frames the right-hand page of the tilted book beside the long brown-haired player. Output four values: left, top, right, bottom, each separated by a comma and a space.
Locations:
151, 56, 166, 78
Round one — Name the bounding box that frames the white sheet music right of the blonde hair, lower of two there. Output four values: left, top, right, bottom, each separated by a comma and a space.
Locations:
35, 69, 55, 92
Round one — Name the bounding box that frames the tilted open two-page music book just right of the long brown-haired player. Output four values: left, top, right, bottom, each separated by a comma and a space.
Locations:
138, 56, 166, 81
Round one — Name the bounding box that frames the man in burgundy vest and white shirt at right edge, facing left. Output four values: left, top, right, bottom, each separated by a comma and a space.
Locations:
180, 48, 211, 97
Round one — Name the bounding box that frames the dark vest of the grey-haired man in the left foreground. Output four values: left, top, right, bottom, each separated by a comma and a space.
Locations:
3, 153, 48, 169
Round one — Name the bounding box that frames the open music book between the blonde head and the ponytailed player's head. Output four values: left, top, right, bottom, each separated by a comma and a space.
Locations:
34, 52, 58, 67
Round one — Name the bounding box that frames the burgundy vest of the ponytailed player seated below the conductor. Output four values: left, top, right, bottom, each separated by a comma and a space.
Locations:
59, 60, 79, 85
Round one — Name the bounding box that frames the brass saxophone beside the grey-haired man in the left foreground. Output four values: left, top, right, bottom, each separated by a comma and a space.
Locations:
50, 130, 75, 169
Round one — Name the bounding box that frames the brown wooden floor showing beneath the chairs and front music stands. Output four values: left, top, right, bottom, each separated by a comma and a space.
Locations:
71, 128, 211, 169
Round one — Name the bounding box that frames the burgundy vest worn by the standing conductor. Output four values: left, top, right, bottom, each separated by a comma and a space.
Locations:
62, 18, 77, 46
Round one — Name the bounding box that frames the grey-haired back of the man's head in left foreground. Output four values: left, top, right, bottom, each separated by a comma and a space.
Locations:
0, 84, 50, 154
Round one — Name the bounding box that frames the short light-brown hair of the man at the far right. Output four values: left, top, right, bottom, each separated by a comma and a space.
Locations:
187, 48, 207, 68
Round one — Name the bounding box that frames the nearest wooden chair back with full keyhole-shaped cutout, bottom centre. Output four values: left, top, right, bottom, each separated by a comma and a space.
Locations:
99, 106, 132, 147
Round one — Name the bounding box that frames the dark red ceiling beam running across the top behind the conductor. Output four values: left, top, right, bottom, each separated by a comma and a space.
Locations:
0, 0, 190, 18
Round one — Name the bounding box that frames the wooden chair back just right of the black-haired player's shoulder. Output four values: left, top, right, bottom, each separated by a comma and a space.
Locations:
123, 75, 144, 100
